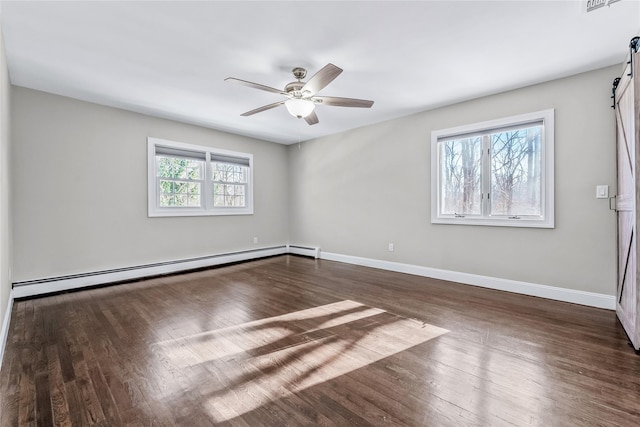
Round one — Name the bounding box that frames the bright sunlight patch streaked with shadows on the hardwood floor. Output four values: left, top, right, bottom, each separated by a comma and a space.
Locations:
157, 300, 448, 422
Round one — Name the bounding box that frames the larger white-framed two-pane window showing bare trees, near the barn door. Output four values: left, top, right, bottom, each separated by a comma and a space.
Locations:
431, 110, 554, 228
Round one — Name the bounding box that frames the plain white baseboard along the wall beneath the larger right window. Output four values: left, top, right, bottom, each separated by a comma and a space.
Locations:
320, 252, 616, 310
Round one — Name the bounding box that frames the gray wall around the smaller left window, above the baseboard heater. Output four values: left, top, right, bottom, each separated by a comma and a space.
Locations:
11, 87, 288, 282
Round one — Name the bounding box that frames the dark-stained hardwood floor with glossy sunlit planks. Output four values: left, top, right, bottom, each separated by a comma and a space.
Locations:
0, 256, 640, 426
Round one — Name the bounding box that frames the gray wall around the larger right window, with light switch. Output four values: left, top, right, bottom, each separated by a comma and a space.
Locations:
289, 66, 621, 295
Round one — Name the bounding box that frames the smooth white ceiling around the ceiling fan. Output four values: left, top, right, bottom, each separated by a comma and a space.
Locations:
0, 0, 640, 144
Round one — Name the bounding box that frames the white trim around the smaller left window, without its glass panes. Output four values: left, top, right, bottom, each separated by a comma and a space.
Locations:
147, 137, 253, 218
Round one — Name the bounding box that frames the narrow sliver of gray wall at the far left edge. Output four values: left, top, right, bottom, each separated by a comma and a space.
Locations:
0, 28, 11, 338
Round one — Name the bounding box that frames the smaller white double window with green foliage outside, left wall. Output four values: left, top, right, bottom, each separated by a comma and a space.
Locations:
147, 138, 253, 217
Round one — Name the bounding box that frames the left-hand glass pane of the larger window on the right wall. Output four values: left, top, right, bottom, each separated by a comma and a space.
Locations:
439, 136, 482, 215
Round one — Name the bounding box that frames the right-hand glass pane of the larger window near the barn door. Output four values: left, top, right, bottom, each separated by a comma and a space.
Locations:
491, 126, 542, 216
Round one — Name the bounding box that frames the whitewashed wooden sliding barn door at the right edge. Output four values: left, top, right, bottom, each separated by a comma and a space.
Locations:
615, 58, 640, 349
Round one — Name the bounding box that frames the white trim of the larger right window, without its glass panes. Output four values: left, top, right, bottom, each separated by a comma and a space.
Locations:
431, 109, 555, 228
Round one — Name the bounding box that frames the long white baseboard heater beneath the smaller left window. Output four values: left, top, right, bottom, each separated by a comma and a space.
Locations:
13, 245, 288, 298
